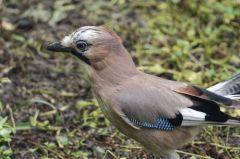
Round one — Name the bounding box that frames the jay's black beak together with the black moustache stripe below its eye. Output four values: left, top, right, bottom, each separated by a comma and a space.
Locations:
44, 42, 91, 65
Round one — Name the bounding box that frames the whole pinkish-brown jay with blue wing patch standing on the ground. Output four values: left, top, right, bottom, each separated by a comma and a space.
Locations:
45, 26, 240, 159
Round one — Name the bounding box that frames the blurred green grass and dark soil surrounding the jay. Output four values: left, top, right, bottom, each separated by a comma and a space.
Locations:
0, 0, 240, 159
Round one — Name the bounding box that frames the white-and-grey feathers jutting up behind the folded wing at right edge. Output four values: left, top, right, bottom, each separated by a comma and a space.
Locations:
207, 73, 240, 108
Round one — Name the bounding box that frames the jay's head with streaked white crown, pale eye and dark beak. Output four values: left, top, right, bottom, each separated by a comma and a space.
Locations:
46, 26, 122, 65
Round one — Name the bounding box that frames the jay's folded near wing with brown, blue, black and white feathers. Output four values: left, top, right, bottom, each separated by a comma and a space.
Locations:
114, 77, 240, 130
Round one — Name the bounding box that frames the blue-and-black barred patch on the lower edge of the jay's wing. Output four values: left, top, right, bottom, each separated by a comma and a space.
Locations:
129, 117, 176, 131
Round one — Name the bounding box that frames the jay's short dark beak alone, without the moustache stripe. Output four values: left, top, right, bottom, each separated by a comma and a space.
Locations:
45, 42, 73, 52
